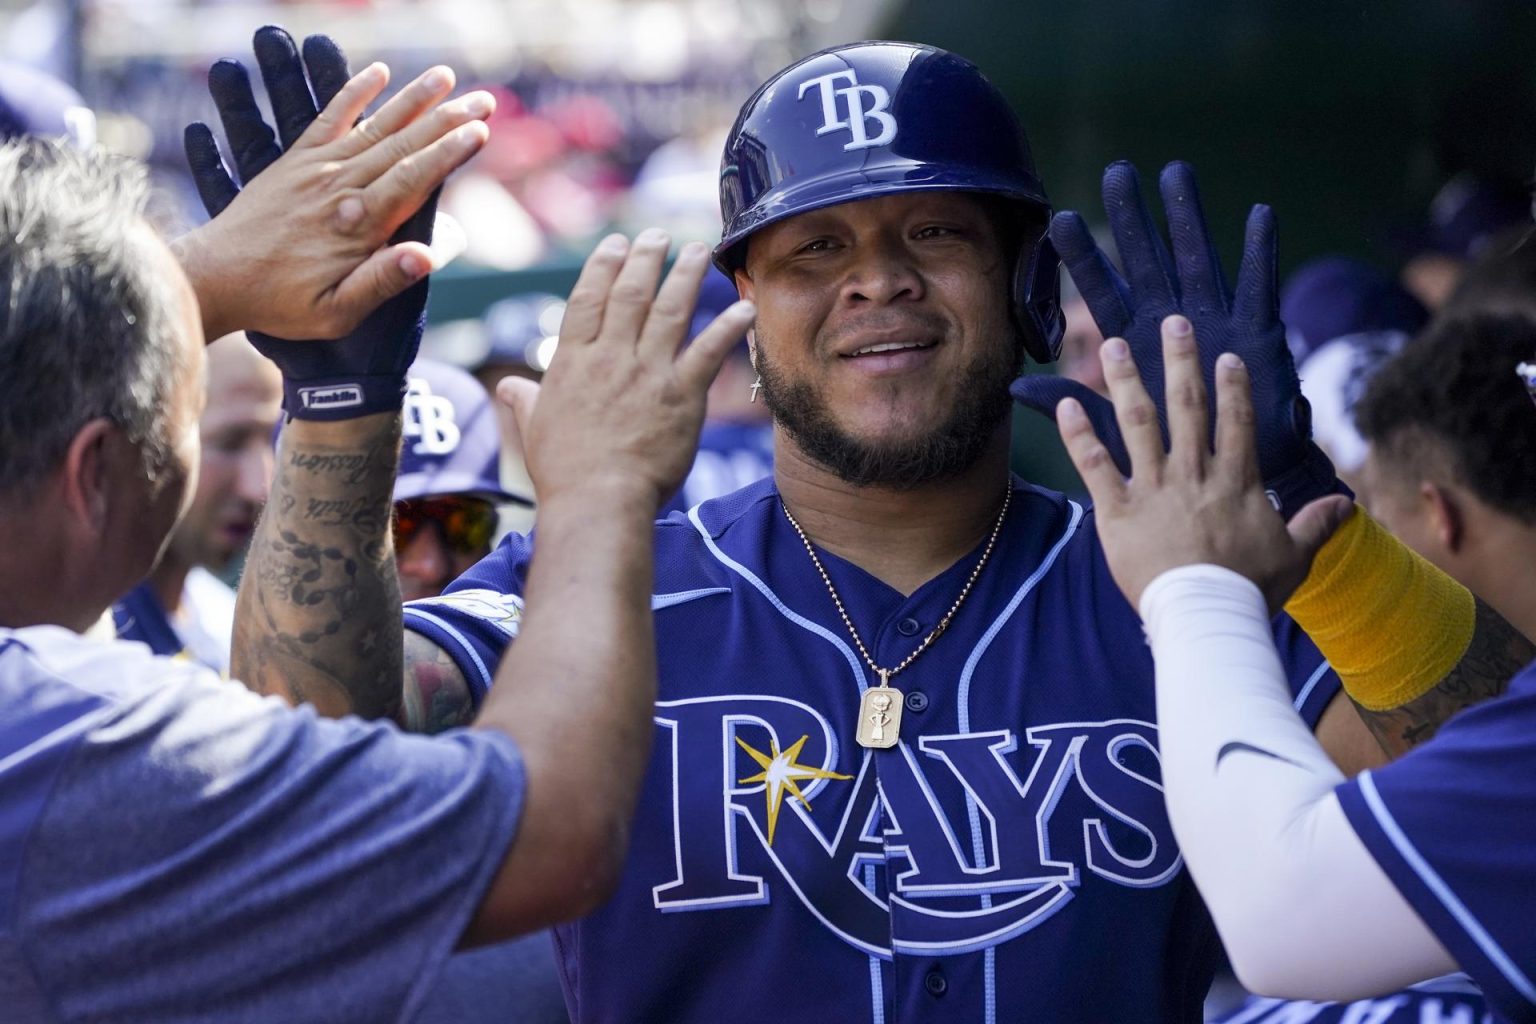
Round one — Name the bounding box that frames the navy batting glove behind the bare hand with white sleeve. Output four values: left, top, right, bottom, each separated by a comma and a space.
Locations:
1012, 161, 1347, 519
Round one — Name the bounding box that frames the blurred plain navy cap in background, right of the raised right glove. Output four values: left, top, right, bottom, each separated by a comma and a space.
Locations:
1279, 256, 1430, 364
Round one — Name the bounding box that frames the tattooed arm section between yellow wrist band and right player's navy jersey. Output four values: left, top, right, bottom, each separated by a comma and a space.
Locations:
1356, 600, 1536, 757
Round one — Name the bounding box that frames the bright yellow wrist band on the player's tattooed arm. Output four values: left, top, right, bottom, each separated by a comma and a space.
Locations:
1286, 505, 1476, 711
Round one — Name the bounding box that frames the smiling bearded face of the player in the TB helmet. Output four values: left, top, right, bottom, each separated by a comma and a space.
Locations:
742, 192, 1040, 490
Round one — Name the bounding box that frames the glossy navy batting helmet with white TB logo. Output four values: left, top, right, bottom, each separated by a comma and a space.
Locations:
714, 41, 1063, 362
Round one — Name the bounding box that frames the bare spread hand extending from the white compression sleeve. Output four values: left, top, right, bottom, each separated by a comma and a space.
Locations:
1057, 316, 1352, 613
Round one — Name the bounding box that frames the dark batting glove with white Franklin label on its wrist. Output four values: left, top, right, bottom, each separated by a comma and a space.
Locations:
186, 25, 438, 419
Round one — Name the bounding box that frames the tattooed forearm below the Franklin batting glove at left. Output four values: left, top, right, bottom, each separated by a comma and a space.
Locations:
232, 416, 401, 717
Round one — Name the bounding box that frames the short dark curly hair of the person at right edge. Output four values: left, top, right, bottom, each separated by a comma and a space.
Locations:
1355, 313, 1536, 525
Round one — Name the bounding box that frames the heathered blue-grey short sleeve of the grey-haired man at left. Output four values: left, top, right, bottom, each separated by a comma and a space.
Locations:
15, 662, 524, 1024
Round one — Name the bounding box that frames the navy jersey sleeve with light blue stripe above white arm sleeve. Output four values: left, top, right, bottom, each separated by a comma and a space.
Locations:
1336, 662, 1536, 1021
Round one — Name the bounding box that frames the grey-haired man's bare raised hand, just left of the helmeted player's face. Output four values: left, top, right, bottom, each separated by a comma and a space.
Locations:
498, 229, 754, 517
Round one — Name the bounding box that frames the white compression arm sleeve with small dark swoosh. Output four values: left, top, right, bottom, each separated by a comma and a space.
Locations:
1141, 565, 1456, 1001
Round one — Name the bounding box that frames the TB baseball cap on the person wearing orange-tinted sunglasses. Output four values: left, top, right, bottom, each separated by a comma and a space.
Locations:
395, 359, 531, 504
